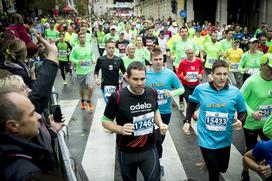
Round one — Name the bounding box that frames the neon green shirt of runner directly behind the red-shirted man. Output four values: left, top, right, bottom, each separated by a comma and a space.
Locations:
172, 39, 198, 67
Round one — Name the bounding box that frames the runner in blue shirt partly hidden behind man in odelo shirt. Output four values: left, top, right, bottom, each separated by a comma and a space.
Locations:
146, 48, 184, 176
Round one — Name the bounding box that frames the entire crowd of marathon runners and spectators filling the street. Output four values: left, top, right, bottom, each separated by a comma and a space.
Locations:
0, 13, 272, 181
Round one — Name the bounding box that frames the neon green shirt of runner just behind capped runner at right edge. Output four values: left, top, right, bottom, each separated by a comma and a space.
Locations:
238, 50, 263, 74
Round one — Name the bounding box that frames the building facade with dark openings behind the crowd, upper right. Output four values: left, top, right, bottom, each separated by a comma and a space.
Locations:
134, 0, 272, 30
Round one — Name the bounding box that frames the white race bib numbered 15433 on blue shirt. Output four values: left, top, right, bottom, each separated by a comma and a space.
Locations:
206, 111, 228, 131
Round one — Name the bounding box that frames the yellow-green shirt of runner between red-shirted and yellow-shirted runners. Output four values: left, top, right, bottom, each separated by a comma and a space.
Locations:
203, 42, 223, 69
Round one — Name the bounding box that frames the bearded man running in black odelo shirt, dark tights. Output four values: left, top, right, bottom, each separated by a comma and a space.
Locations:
102, 62, 167, 181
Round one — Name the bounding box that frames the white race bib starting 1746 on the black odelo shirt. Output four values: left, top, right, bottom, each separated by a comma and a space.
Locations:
133, 112, 154, 136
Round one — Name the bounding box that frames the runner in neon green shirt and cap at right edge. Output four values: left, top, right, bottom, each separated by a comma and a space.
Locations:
241, 53, 272, 181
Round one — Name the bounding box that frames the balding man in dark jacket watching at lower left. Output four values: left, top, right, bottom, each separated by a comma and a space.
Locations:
0, 91, 59, 180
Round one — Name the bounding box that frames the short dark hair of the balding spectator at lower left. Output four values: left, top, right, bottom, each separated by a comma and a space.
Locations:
0, 91, 23, 131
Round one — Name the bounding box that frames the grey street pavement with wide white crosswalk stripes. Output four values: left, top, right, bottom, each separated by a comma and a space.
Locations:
54, 40, 261, 181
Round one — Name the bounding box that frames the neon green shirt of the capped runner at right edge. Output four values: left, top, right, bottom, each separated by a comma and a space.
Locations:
241, 73, 272, 130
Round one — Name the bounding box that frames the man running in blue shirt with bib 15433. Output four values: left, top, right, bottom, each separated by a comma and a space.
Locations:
184, 60, 247, 181
